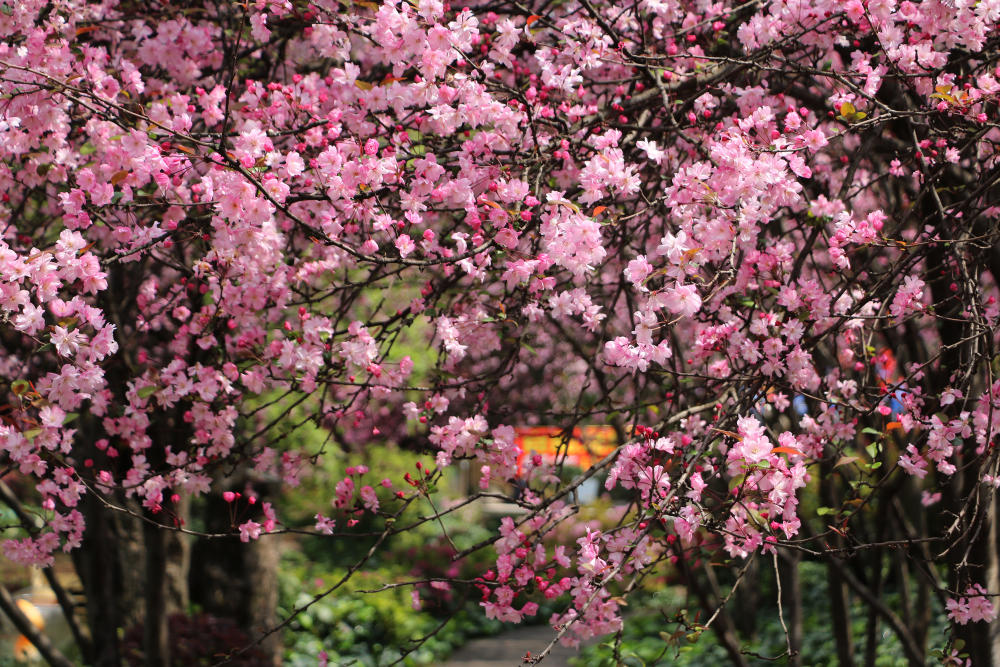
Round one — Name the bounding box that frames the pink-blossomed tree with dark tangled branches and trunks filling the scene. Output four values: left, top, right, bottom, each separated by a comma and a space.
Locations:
0, 0, 1000, 665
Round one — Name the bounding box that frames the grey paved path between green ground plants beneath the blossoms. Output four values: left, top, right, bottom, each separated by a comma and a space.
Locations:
443, 625, 578, 667
